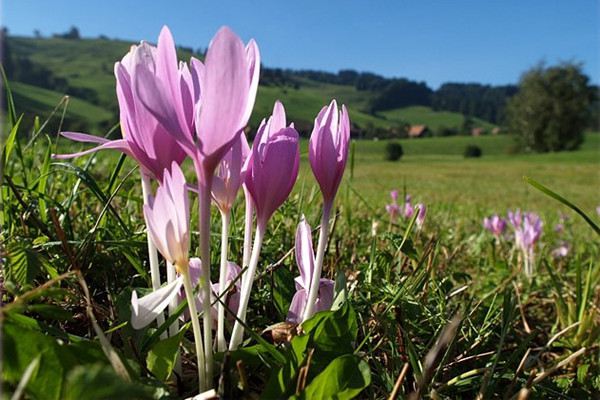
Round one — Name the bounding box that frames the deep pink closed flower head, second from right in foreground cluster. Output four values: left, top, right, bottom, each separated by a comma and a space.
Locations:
245, 102, 300, 224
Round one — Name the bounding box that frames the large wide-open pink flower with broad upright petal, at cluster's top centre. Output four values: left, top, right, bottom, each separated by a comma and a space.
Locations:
135, 27, 260, 179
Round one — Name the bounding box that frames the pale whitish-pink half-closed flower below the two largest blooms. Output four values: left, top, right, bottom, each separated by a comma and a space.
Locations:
144, 162, 190, 269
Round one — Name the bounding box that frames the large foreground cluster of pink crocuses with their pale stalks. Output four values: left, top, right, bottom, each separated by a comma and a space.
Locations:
55, 27, 350, 391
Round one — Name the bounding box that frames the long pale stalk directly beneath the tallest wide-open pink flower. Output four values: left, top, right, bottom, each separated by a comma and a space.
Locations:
198, 180, 213, 388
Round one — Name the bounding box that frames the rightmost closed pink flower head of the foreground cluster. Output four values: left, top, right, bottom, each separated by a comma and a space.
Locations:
308, 100, 350, 204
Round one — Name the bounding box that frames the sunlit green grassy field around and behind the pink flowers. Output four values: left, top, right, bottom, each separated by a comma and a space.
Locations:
0, 85, 600, 399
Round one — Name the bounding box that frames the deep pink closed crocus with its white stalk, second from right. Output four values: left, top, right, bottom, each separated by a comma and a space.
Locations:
229, 102, 300, 350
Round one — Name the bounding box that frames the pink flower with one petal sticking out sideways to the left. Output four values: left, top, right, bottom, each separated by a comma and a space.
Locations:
54, 27, 194, 181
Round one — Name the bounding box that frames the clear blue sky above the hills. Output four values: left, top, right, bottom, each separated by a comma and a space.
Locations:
2, 0, 600, 88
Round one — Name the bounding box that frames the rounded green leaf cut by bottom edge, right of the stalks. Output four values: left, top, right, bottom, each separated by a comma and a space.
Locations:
294, 354, 371, 400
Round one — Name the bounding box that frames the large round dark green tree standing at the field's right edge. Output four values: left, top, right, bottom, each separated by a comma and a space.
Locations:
507, 63, 594, 152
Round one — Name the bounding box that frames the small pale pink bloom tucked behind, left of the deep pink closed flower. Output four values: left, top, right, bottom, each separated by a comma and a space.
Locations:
212, 134, 250, 213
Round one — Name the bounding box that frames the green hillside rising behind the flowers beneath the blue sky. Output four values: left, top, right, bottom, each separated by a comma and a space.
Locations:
5, 37, 493, 137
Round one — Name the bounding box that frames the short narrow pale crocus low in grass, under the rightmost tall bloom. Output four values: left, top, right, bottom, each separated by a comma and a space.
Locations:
287, 217, 334, 323
